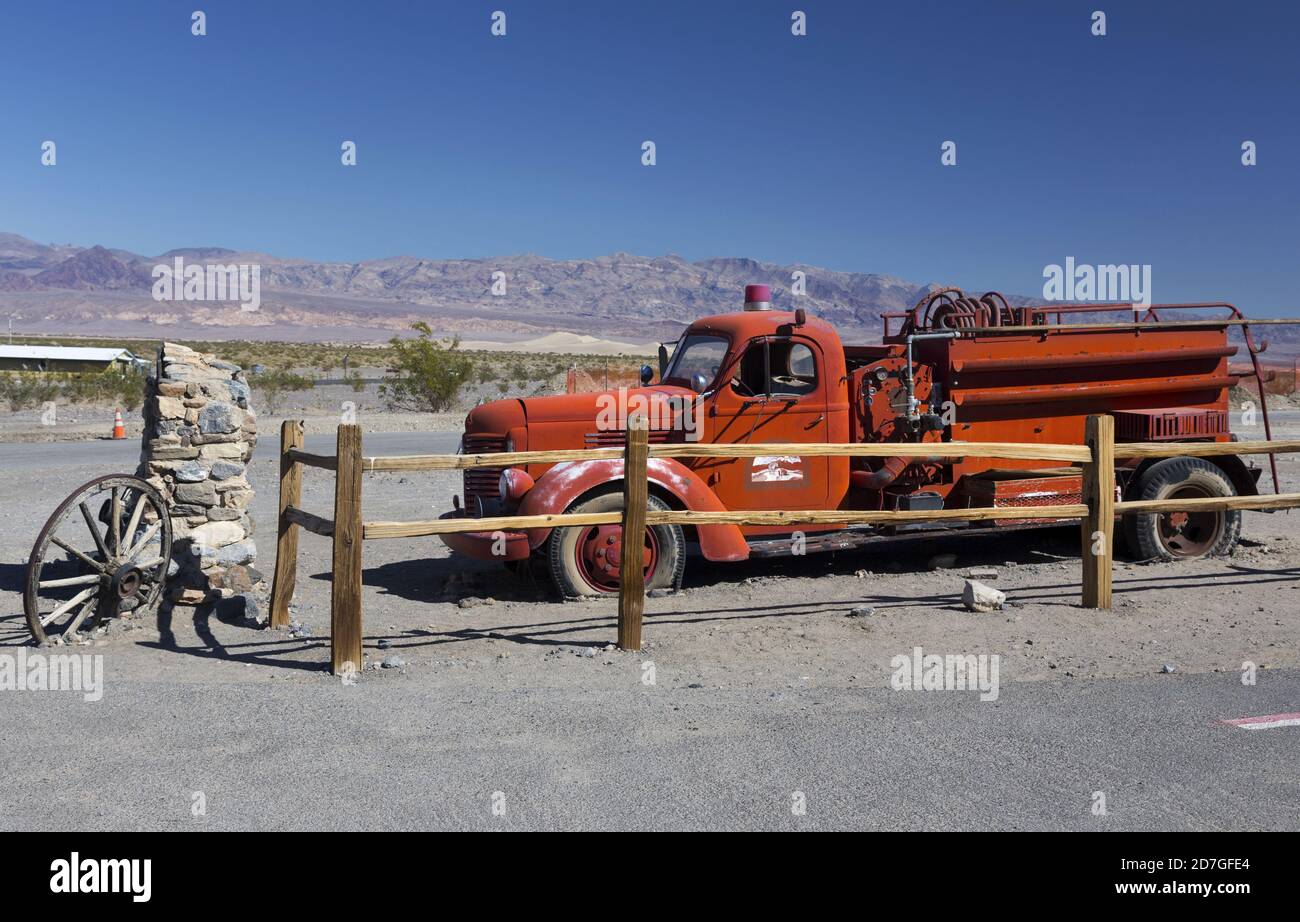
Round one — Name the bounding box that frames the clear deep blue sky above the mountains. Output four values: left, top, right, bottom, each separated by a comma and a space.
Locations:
0, 0, 1300, 315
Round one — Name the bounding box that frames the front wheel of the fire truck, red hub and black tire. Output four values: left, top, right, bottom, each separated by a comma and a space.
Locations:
546, 493, 686, 598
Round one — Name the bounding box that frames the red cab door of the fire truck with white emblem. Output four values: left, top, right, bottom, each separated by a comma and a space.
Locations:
697, 336, 829, 510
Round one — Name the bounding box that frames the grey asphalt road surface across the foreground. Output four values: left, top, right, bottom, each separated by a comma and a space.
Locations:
0, 658, 1300, 830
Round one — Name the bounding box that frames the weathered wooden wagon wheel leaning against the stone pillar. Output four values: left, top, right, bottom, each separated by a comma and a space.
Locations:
22, 473, 172, 644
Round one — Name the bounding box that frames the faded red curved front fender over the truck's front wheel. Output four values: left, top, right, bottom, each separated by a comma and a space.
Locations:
519, 458, 749, 560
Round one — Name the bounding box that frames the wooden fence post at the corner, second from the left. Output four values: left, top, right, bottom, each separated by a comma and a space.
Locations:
330, 425, 361, 675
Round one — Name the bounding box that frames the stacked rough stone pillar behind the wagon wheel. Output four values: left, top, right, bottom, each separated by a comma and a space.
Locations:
139, 342, 264, 620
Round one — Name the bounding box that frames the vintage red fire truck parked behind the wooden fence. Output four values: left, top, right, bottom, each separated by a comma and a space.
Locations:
442, 285, 1277, 596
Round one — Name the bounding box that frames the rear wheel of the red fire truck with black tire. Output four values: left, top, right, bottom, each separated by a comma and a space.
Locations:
1122, 458, 1242, 560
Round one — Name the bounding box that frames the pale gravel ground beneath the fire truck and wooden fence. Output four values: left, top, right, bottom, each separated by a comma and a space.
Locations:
0, 420, 1300, 687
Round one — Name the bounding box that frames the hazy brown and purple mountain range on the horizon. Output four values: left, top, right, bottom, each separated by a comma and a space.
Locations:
0, 233, 935, 342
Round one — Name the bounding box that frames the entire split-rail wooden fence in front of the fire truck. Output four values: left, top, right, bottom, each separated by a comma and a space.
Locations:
270, 415, 1300, 674
